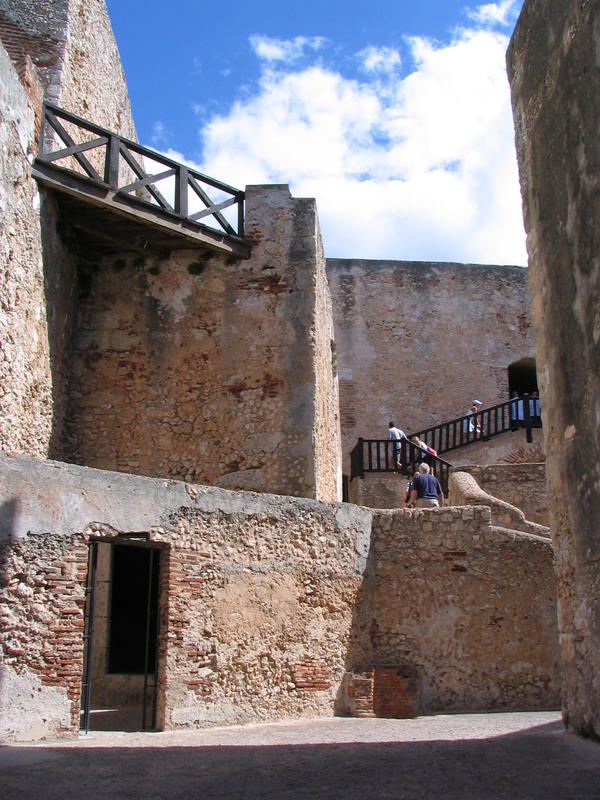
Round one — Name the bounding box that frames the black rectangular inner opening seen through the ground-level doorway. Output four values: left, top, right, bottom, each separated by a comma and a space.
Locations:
108, 545, 160, 675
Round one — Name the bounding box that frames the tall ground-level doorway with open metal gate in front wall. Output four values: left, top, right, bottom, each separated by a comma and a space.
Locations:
81, 536, 163, 731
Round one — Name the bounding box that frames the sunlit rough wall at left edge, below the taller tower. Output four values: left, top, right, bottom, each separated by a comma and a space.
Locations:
0, 45, 52, 455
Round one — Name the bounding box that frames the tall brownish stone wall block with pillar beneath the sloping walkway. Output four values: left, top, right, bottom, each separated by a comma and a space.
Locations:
64, 186, 340, 500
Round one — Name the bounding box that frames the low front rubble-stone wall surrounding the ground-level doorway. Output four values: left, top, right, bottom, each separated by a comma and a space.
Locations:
0, 456, 559, 738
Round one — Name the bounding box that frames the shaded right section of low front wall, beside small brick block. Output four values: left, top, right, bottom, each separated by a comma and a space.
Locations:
372, 507, 560, 713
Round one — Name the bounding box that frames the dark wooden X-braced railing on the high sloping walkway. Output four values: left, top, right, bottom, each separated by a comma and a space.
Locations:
37, 103, 245, 238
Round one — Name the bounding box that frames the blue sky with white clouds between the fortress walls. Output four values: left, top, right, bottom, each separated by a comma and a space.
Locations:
107, 0, 526, 264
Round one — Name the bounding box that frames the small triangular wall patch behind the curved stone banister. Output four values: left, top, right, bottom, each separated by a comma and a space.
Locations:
460, 463, 550, 526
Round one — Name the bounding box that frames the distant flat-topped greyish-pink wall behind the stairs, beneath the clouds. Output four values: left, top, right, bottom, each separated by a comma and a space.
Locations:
327, 259, 533, 472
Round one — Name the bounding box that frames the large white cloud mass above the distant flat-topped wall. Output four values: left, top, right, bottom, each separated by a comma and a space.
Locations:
195, 27, 527, 264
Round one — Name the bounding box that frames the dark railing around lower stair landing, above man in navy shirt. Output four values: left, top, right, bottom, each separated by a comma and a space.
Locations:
350, 439, 452, 494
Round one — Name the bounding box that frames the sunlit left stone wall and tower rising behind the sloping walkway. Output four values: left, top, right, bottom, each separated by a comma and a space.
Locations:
0, 0, 135, 455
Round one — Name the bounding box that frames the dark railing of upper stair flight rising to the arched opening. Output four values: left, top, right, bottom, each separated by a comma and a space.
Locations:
409, 394, 542, 453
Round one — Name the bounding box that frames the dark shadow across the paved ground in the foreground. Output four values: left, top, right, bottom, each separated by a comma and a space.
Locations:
1, 721, 600, 800
